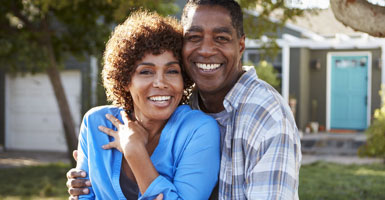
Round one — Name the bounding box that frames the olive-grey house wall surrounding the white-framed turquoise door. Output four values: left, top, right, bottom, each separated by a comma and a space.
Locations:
301, 49, 381, 130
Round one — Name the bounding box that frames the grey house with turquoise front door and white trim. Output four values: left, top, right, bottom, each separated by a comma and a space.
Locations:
243, 9, 385, 131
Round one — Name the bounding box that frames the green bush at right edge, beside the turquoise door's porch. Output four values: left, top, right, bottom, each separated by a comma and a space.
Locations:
358, 91, 385, 160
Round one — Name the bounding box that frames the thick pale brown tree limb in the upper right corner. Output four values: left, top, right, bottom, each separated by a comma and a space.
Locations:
330, 0, 385, 37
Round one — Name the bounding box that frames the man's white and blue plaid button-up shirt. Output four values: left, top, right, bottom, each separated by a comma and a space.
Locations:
191, 69, 301, 199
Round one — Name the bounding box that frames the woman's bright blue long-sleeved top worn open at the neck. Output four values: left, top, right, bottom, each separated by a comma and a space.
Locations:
77, 105, 220, 200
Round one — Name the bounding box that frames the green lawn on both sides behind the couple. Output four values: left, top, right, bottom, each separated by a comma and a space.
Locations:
0, 162, 385, 200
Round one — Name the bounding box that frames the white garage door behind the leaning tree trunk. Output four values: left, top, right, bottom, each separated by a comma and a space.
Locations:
0, 57, 98, 152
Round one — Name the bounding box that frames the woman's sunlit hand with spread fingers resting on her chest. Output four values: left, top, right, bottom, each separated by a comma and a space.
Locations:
98, 111, 148, 156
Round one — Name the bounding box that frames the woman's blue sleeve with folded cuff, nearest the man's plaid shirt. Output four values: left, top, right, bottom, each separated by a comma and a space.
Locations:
139, 120, 220, 200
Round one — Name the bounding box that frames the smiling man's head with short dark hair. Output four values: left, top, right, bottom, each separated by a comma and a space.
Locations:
182, 6, 245, 95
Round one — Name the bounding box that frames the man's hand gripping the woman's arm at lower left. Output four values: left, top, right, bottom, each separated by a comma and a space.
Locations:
66, 150, 91, 200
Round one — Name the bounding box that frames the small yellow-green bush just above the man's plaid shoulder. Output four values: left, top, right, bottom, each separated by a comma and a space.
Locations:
245, 60, 281, 91
